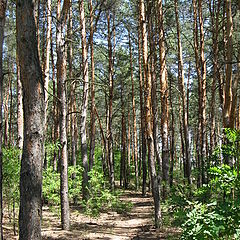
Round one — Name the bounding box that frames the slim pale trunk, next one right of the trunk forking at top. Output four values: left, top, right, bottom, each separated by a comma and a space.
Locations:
79, 0, 89, 200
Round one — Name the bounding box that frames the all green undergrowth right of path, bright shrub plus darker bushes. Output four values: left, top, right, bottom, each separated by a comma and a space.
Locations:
165, 129, 240, 240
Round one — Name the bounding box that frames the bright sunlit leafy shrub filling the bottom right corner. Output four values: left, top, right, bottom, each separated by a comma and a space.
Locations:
182, 129, 240, 240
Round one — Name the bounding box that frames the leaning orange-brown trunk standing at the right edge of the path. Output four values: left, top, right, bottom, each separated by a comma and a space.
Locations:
139, 0, 162, 228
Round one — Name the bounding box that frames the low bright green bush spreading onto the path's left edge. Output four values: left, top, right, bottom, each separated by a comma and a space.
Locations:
84, 169, 132, 216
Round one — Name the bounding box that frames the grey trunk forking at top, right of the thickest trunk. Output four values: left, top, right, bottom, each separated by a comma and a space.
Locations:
57, 0, 70, 230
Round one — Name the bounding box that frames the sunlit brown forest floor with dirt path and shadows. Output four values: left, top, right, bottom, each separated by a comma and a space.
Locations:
5, 191, 180, 240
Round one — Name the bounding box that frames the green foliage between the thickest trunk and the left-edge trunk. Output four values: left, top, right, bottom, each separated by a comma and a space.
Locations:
2, 147, 21, 205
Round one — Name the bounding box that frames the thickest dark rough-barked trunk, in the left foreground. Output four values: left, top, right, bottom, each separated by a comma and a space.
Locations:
17, 0, 44, 240
